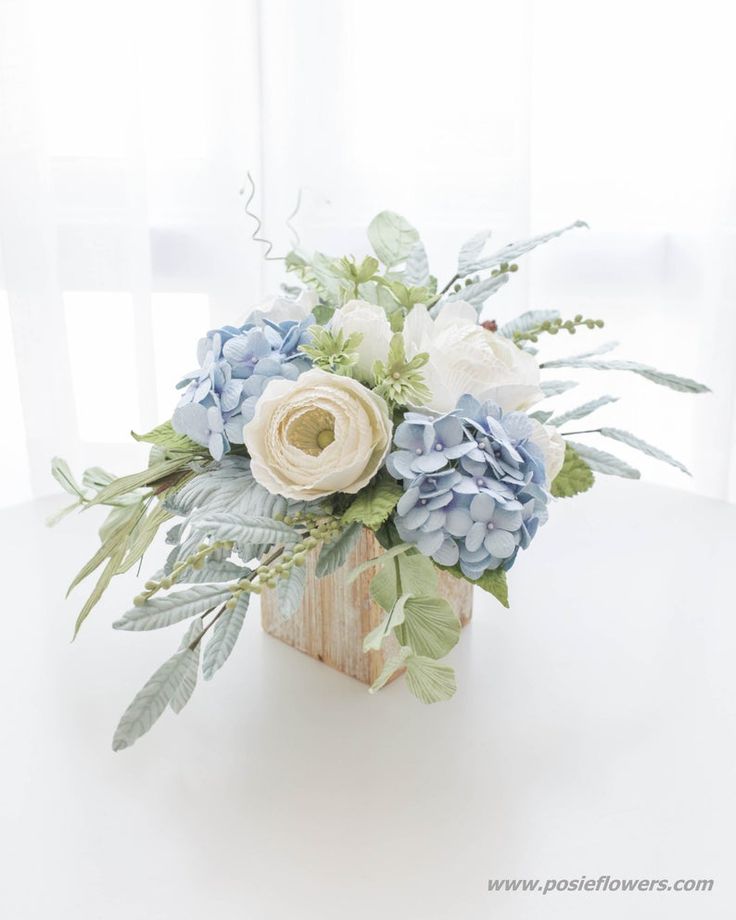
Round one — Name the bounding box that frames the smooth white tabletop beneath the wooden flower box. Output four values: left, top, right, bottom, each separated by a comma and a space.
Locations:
0, 480, 736, 920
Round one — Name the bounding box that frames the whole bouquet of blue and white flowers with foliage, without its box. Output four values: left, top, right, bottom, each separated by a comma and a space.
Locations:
53, 211, 707, 750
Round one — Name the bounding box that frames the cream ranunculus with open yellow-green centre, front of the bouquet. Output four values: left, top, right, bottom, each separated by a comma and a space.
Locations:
243, 369, 391, 501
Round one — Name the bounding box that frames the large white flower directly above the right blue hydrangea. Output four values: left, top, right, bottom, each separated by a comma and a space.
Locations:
404, 300, 544, 412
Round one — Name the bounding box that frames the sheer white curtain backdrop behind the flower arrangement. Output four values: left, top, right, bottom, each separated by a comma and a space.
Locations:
0, 0, 736, 503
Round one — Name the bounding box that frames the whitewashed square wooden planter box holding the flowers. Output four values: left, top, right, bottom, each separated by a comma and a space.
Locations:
261, 530, 473, 684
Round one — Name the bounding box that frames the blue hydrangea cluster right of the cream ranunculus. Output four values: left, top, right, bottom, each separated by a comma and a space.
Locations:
386, 396, 548, 579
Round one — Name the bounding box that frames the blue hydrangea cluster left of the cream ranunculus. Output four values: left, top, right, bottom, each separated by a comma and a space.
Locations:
171, 316, 314, 460
